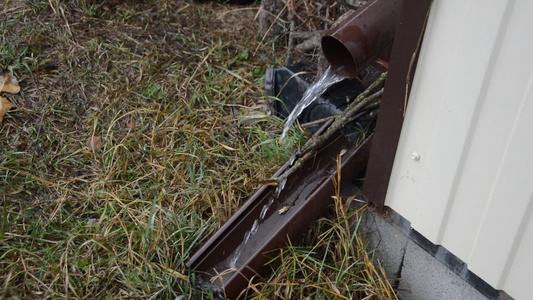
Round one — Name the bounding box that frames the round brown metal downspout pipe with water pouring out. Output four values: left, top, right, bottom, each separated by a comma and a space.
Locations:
321, 0, 402, 78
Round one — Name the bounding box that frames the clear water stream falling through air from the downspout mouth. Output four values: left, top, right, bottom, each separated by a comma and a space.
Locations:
279, 67, 344, 141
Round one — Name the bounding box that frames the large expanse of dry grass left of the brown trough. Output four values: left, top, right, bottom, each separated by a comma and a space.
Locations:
0, 0, 394, 299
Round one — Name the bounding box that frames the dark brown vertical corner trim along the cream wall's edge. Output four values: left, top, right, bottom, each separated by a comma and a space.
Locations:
363, 0, 433, 213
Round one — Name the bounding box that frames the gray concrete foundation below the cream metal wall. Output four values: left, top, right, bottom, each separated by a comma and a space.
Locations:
362, 212, 511, 300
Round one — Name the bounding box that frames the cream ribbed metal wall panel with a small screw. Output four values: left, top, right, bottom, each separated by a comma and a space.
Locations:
385, 0, 533, 299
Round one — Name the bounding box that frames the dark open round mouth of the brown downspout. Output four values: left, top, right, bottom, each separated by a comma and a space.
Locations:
321, 35, 357, 78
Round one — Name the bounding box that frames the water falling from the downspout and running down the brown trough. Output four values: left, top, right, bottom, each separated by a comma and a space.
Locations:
194, 69, 354, 293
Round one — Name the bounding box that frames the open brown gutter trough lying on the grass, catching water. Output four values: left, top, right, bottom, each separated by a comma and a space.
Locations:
187, 135, 372, 299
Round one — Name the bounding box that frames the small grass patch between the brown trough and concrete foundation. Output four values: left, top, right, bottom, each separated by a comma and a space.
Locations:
243, 156, 397, 299
